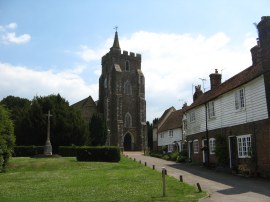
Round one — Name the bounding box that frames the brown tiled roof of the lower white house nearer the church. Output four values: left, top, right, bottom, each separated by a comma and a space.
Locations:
158, 109, 183, 132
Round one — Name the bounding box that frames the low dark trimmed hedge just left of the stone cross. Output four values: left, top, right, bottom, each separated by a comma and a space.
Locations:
13, 145, 44, 157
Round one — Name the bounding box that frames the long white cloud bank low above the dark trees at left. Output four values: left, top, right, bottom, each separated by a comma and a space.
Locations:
0, 63, 98, 104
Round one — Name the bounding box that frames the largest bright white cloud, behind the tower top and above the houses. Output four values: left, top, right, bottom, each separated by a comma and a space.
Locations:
77, 31, 255, 121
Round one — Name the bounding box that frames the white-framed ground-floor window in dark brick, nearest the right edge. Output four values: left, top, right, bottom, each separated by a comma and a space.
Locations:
237, 135, 251, 158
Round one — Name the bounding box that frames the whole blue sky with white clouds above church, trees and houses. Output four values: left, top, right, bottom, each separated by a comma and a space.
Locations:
0, 0, 270, 122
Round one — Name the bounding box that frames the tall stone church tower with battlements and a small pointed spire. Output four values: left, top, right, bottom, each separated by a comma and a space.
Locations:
98, 31, 147, 151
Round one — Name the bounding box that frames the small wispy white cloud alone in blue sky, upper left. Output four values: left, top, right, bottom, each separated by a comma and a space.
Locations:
0, 22, 31, 44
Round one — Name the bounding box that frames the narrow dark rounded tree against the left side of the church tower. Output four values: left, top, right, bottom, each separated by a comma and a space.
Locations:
89, 113, 107, 146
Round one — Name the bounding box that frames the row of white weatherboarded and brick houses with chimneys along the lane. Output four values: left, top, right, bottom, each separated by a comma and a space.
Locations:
153, 16, 270, 177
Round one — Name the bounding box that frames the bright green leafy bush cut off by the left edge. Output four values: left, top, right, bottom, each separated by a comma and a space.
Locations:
0, 105, 15, 172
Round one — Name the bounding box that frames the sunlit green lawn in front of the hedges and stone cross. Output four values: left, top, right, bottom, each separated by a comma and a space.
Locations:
0, 157, 206, 202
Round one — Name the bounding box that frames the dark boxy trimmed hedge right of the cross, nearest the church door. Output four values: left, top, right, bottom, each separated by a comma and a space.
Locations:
76, 146, 120, 162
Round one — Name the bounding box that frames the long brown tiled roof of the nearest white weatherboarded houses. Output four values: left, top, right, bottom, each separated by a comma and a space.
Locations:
185, 63, 263, 111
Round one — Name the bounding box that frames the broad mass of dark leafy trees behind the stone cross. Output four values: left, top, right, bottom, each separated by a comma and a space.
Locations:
1, 94, 87, 148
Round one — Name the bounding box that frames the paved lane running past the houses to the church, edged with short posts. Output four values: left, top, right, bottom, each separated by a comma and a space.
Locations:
124, 152, 270, 202
